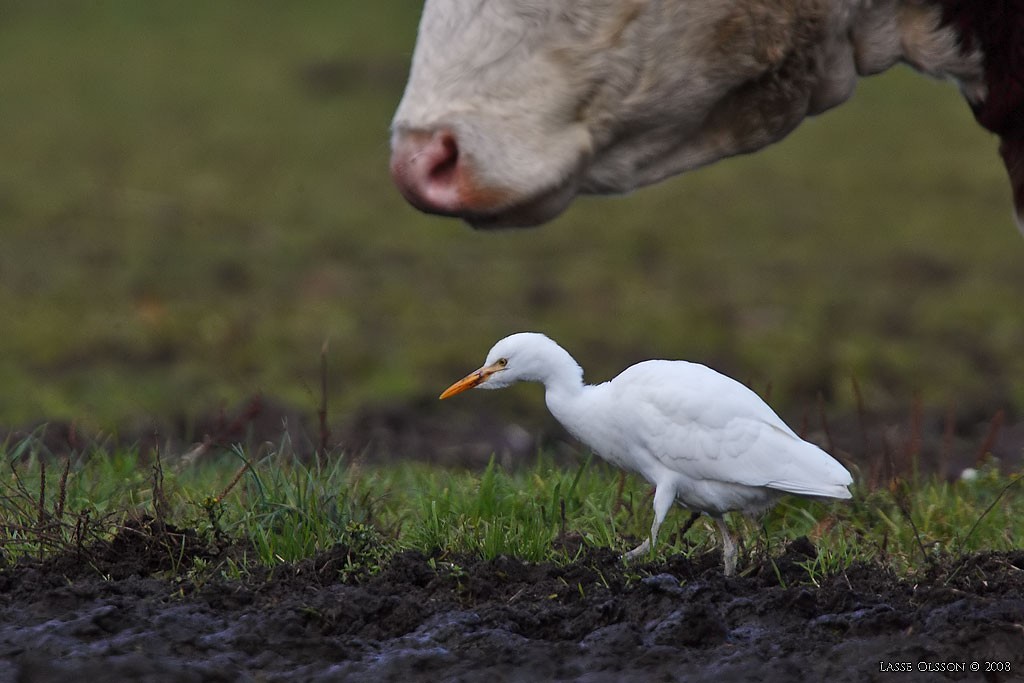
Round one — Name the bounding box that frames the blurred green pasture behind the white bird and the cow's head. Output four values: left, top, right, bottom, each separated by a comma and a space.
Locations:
0, 0, 1024, 428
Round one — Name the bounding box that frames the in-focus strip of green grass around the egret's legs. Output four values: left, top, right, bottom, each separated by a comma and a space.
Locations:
0, 439, 1024, 584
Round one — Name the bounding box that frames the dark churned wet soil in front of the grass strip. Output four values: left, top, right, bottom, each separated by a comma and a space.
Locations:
0, 520, 1024, 683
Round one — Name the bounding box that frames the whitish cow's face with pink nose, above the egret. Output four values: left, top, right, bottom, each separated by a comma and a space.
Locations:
391, 0, 855, 226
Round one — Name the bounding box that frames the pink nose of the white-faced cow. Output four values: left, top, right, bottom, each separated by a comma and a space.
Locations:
391, 129, 465, 214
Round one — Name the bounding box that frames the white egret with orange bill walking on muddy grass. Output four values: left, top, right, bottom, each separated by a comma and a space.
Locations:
440, 332, 853, 575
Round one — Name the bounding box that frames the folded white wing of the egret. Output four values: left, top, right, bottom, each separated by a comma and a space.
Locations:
609, 361, 852, 498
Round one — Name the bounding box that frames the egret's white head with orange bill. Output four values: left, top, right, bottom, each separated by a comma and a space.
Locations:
440, 332, 582, 399
